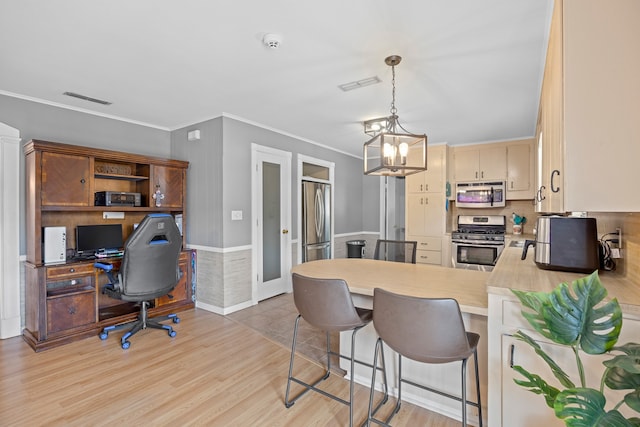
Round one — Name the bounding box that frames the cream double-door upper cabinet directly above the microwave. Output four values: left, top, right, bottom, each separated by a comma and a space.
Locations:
453, 144, 507, 182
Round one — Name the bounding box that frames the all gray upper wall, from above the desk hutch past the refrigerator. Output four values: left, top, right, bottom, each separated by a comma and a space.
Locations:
0, 95, 379, 254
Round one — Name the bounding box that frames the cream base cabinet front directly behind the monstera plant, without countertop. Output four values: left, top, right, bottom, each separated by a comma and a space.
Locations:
487, 290, 640, 427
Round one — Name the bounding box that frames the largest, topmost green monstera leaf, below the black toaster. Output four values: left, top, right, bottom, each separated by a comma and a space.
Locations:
512, 270, 622, 354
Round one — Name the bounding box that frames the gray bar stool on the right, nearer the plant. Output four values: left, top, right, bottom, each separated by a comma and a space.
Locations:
366, 288, 482, 427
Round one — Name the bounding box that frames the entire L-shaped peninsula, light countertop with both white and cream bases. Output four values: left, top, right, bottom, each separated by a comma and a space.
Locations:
292, 252, 640, 427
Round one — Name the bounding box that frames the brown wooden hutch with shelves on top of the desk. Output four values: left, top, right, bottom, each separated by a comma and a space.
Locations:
24, 140, 189, 266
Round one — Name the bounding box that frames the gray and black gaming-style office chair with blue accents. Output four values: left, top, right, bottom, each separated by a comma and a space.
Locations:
95, 213, 182, 349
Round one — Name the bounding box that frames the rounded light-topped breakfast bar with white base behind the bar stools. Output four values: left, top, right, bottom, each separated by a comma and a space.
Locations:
292, 258, 490, 419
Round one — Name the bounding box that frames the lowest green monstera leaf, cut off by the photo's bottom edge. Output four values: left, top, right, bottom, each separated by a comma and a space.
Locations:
554, 388, 633, 427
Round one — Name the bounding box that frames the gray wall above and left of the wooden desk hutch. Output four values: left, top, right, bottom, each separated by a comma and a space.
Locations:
0, 94, 171, 254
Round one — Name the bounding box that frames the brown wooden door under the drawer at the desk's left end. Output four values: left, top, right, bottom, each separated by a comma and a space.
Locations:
47, 292, 96, 333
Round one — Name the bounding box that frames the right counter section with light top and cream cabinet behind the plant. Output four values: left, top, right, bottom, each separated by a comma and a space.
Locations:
487, 239, 640, 427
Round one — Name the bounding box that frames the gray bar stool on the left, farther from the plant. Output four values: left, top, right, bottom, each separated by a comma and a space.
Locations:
284, 273, 388, 426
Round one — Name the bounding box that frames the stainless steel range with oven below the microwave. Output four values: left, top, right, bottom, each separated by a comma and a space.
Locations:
451, 215, 507, 271
